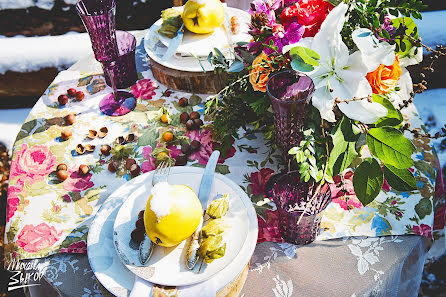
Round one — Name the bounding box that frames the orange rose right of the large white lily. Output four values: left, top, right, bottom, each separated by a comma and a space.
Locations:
367, 55, 401, 94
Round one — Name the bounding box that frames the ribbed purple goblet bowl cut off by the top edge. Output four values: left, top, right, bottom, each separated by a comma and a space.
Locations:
76, 0, 118, 62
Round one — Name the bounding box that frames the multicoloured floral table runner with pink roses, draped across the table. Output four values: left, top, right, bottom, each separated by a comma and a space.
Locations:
5, 65, 445, 258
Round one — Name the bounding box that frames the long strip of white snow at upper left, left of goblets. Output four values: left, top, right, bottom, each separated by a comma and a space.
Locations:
0, 32, 93, 74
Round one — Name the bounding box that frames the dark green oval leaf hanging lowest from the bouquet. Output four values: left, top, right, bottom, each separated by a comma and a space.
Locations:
353, 158, 384, 206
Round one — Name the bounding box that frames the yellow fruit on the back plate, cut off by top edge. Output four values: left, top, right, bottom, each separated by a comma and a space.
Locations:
183, 0, 225, 34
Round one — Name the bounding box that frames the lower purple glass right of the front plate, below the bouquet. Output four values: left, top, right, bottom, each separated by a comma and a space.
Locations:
266, 171, 331, 245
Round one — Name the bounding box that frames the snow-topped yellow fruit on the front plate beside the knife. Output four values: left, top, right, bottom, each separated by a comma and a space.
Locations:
144, 182, 203, 247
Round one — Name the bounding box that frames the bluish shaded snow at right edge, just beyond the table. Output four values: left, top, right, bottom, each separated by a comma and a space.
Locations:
414, 86, 446, 167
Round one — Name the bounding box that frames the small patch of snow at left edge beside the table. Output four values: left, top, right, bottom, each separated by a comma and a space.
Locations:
0, 108, 31, 149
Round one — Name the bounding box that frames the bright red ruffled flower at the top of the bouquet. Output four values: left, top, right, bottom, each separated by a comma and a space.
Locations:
280, 0, 333, 37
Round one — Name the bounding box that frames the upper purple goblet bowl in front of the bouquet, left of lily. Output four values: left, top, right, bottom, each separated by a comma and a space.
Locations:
266, 70, 314, 161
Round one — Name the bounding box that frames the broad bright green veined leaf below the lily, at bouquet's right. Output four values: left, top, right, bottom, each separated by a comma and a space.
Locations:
367, 127, 415, 169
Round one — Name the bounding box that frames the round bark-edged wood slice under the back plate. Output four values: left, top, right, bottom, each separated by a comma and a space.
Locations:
149, 58, 226, 94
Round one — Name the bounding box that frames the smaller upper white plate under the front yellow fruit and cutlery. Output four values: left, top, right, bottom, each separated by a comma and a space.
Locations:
113, 166, 249, 286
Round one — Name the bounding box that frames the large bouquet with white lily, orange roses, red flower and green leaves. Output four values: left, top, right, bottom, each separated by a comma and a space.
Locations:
206, 0, 446, 205
